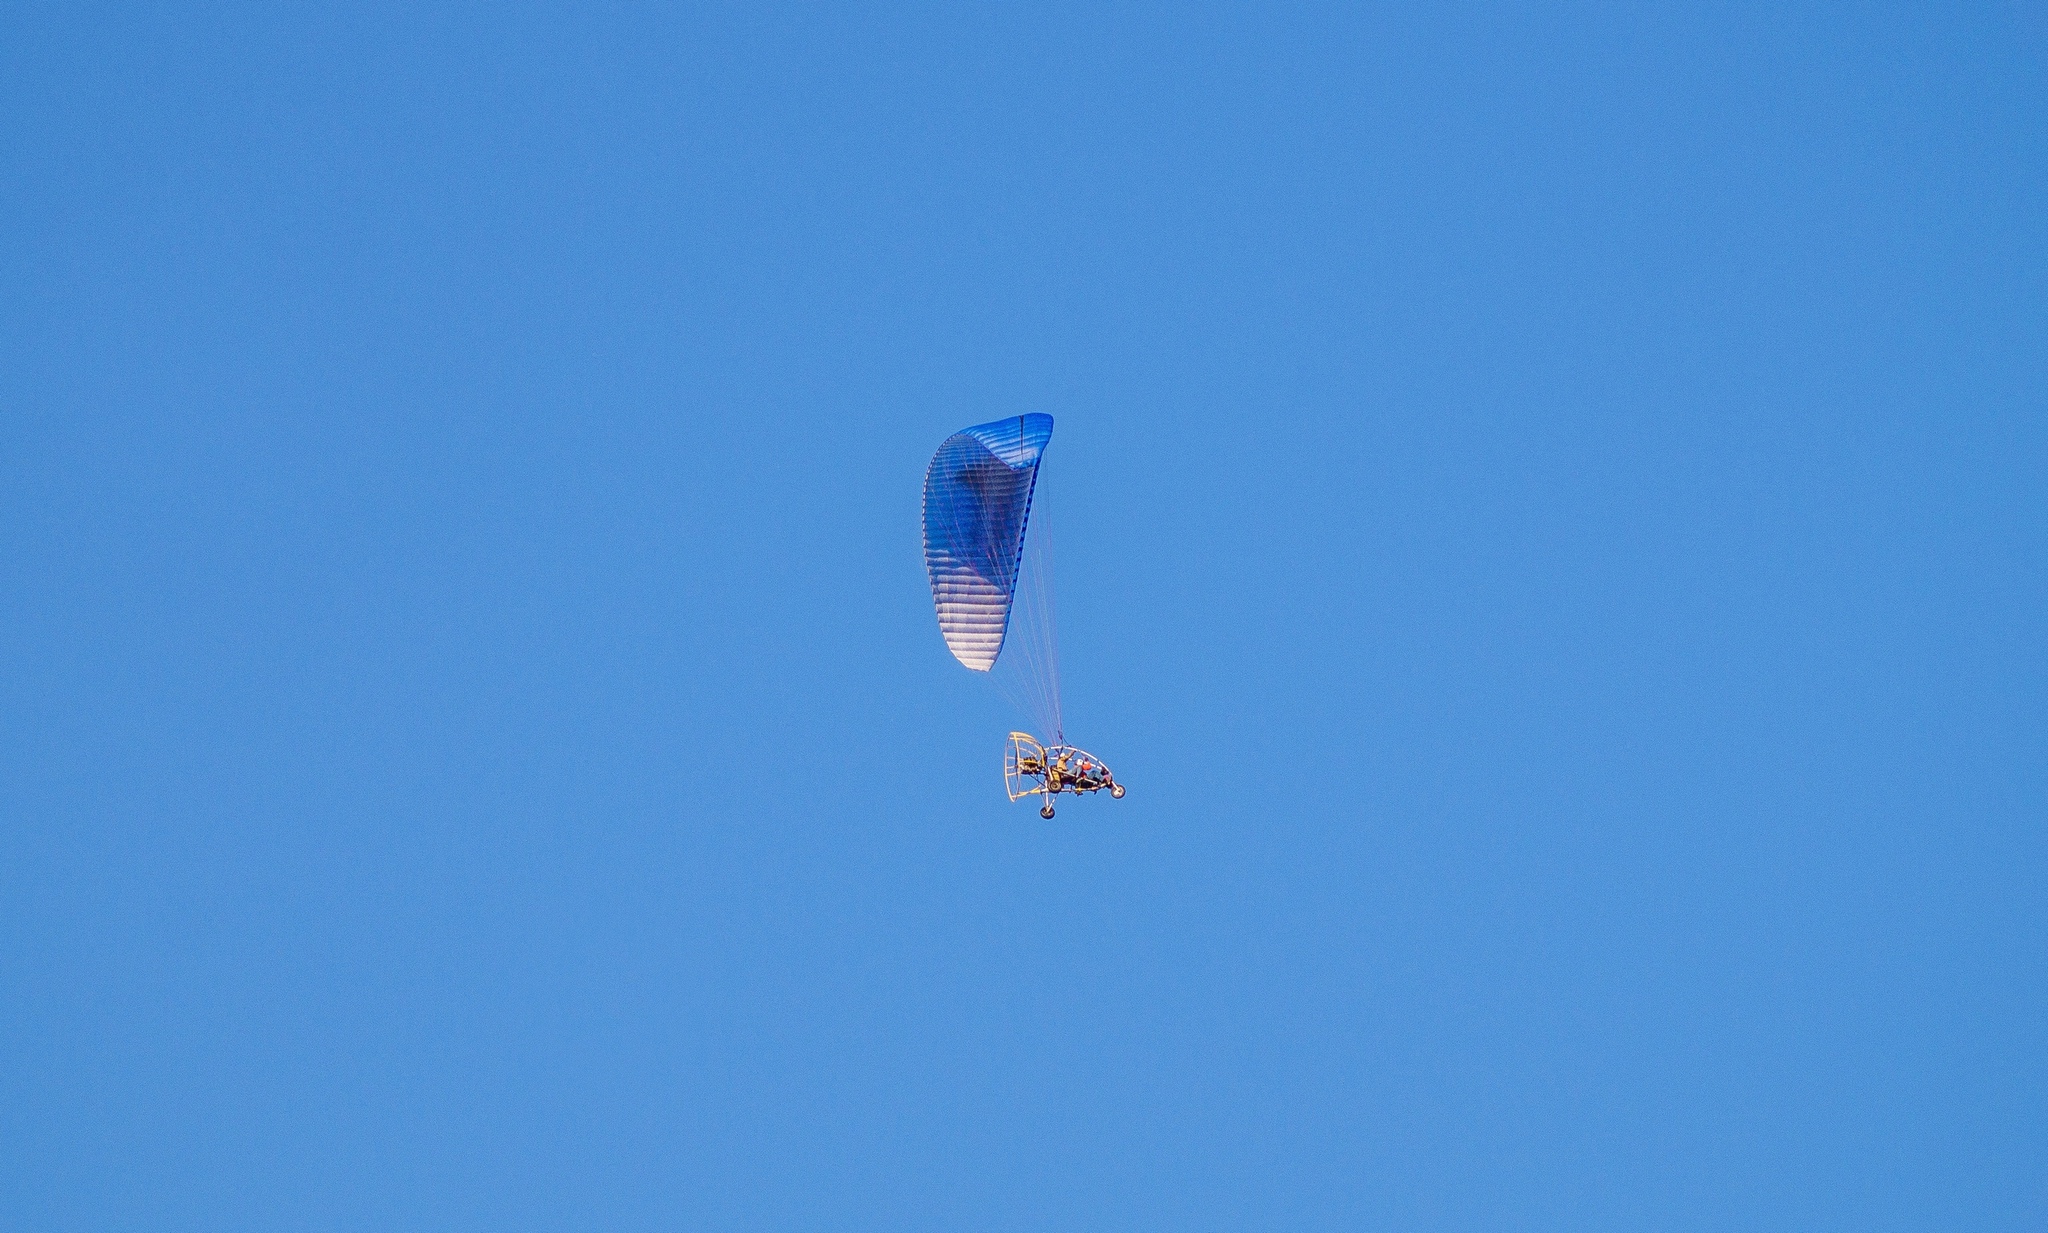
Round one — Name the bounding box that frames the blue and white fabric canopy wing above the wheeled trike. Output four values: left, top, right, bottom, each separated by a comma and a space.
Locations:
924, 416, 1053, 672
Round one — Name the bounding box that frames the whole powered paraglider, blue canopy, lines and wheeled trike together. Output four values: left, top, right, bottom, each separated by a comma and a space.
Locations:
924, 414, 1124, 817
